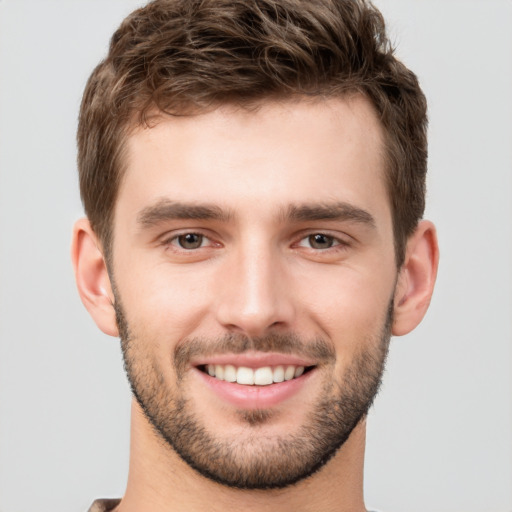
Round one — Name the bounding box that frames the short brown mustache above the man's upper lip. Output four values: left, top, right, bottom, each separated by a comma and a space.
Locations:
174, 333, 336, 375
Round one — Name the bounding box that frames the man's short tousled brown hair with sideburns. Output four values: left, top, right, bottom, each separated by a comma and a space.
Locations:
78, 0, 427, 265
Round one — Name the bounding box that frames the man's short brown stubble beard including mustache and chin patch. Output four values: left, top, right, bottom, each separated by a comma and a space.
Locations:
114, 294, 393, 489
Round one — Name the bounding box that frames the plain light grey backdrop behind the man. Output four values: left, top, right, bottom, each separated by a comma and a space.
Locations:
0, 0, 512, 512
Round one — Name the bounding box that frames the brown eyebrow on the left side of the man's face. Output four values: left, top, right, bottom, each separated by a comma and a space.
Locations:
137, 199, 232, 227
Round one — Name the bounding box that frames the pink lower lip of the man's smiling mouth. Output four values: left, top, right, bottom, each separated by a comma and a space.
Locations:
195, 368, 315, 409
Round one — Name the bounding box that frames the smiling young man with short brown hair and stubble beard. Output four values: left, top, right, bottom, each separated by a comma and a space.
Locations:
72, 0, 438, 512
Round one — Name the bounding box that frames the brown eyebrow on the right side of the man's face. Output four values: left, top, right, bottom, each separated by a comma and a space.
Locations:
283, 202, 376, 228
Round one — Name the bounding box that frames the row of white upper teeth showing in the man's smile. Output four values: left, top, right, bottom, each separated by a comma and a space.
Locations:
206, 364, 304, 386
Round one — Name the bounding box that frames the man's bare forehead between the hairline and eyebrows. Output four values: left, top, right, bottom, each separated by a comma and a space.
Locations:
115, 95, 389, 228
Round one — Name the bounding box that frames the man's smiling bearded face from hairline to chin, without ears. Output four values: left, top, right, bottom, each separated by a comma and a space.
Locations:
110, 97, 397, 488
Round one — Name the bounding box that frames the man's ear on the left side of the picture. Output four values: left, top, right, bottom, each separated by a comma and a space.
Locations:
71, 219, 119, 336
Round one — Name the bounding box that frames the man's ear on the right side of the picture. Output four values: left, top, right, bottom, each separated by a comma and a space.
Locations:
391, 221, 439, 336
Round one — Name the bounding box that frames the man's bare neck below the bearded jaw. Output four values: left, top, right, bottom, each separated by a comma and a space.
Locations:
116, 402, 366, 512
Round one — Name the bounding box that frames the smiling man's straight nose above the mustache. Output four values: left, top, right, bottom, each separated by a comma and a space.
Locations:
217, 244, 295, 337
